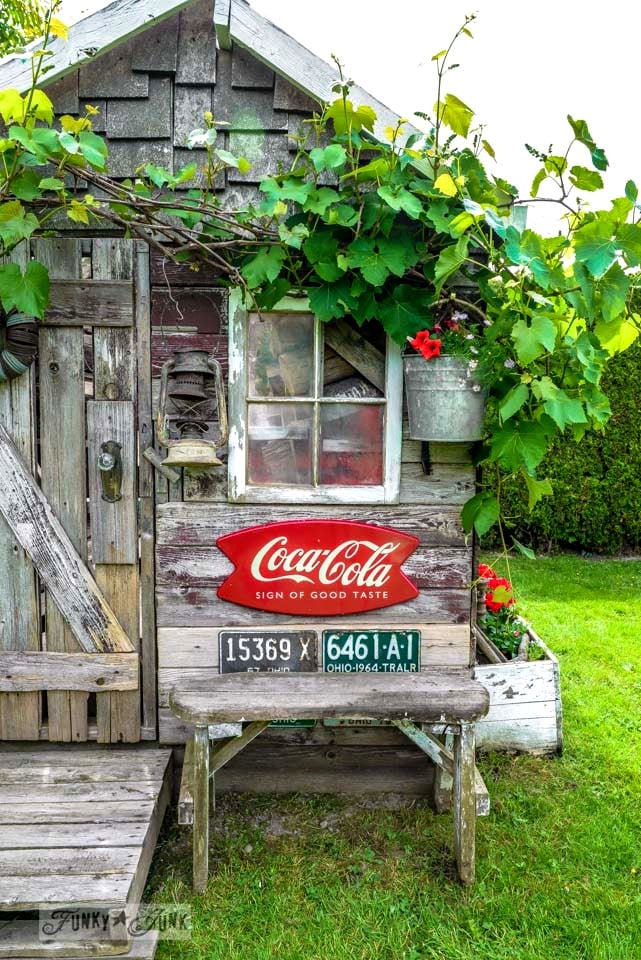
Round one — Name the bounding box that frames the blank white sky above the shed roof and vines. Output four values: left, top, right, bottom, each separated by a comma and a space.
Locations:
62, 0, 641, 231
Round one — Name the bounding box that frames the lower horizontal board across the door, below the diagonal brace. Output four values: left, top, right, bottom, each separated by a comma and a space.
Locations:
0, 651, 138, 688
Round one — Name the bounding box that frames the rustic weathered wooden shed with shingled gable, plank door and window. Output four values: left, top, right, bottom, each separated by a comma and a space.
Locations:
0, 0, 484, 944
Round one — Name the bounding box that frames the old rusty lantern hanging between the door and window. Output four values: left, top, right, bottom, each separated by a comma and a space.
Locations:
158, 350, 228, 470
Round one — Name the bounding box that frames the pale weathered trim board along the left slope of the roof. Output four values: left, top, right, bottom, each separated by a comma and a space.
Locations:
1, 0, 195, 95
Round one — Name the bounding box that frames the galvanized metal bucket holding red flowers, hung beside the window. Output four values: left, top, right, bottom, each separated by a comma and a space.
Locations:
403, 354, 486, 443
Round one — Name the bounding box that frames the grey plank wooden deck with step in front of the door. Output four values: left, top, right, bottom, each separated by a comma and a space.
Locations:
0, 746, 171, 960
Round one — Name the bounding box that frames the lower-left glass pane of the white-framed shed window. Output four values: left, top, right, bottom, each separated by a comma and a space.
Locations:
247, 403, 313, 485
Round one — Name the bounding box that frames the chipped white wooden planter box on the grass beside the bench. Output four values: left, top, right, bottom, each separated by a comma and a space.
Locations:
472, 625, 563, 754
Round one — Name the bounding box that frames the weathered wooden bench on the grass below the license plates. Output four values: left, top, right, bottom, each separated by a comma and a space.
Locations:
170, 668, 489, 891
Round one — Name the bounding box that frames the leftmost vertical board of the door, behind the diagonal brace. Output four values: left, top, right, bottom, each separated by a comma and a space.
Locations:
0, 262, 41, 740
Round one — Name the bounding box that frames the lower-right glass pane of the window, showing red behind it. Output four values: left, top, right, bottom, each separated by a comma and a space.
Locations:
319, 403, 385, 487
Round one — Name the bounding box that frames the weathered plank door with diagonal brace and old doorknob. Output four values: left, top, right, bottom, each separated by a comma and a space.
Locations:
0, 238, 156, 743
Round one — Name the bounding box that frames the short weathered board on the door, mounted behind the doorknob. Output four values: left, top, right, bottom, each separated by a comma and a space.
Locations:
87, 400, 138, 564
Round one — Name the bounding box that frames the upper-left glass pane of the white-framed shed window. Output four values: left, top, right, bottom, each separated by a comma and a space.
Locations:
247, 313, 314, 397
